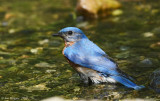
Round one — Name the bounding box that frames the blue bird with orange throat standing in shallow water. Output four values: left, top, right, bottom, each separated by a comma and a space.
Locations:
53, 27, 144, 90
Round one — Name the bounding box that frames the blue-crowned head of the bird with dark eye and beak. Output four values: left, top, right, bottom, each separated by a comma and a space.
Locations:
53, 27, 87, 42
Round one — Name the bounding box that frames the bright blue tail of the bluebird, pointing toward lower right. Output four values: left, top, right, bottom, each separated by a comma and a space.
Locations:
110, 76, 145, 90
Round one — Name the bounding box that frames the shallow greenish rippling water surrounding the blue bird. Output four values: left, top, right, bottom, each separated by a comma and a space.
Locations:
0, 0, 160, 101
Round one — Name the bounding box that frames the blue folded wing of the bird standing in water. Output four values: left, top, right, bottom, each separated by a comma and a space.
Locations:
64, 39, 118, 75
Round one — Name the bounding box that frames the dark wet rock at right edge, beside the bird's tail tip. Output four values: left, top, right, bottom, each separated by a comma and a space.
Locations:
149, 68, 160, 93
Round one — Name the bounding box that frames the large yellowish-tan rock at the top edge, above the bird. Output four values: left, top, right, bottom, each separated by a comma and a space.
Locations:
76, 0, 121, 18
